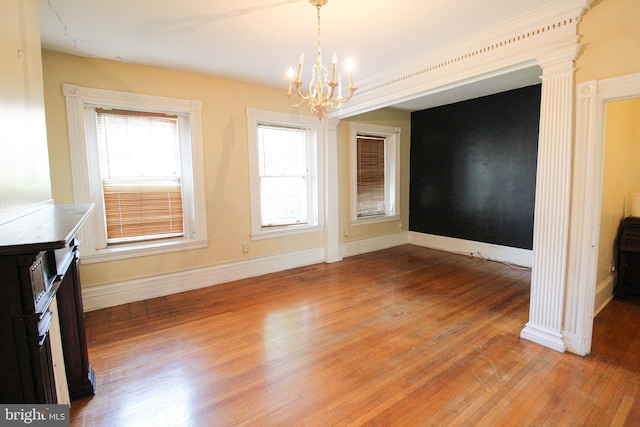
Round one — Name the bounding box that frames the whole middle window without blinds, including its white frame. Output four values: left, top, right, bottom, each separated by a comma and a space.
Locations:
247, 109, 324, 239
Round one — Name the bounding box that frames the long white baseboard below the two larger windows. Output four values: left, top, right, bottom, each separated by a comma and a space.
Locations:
82, 248, 324, 311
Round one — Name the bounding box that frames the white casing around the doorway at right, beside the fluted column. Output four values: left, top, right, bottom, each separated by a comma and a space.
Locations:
563, 73, 640, 355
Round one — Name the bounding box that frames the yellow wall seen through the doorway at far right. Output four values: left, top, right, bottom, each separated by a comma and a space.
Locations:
597, 99, 640, 283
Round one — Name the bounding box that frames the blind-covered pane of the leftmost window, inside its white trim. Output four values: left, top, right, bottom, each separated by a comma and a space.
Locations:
96, 108, 184, 245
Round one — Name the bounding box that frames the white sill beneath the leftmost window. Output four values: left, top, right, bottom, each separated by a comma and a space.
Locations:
80, 239, 209, 264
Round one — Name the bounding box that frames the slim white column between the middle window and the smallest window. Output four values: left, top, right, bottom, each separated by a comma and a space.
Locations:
324, 118, 342, 262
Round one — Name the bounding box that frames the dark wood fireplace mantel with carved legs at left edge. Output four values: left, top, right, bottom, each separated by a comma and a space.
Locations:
0, 205, 95, 403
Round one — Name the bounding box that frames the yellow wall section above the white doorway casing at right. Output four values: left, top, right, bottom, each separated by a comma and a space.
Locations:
576, 0, 640, 83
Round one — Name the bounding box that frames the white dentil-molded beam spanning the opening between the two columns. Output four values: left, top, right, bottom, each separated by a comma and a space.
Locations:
334, 0, 591, 117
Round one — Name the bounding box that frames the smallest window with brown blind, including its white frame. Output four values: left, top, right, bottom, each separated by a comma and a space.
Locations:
351, 123, 400, 223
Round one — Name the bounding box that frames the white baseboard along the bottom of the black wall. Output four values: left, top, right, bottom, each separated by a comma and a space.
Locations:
409, 231, 533, 268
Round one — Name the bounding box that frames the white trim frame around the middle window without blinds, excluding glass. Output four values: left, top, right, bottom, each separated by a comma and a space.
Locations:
246, 108, 326, 240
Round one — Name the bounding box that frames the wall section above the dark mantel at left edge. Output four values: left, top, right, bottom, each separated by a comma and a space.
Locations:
0, 0, 51, 215
